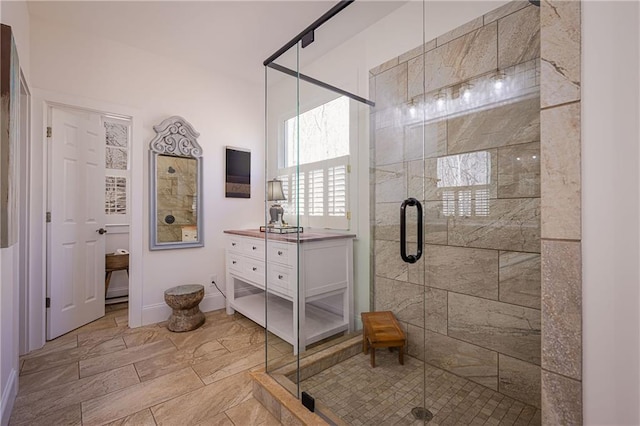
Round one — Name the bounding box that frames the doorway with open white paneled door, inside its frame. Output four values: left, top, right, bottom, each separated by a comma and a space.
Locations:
46, 105, 131, 340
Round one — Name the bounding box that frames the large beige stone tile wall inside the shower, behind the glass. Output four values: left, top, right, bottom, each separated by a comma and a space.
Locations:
370, 2, 544, 408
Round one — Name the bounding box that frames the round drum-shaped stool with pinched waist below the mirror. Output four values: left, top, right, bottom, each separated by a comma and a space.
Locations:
164, 284, 205, 332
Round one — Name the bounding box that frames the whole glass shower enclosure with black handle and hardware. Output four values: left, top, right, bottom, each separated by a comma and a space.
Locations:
264, 1, 541, 424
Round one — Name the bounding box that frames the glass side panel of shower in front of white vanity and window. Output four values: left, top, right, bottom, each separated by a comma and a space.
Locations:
264, 35, 360, 397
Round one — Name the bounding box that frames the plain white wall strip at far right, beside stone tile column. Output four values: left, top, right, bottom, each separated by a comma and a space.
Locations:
582, 1, 640, 425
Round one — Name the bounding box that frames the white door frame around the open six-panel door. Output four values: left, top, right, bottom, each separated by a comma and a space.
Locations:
26, 89, 146, 351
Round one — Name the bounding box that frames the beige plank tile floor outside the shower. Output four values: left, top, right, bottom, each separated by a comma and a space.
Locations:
9, 304, 290, 426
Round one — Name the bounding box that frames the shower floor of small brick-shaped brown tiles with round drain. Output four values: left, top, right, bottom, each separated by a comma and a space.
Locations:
301, 350, 541, 426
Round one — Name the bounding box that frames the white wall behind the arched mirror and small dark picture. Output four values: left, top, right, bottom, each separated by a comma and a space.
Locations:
31, 18, 264, 326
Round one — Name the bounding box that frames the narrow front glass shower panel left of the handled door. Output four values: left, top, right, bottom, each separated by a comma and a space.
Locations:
262, 41, 304, 380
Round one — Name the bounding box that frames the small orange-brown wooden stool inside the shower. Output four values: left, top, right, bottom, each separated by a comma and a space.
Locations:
360, 311, 406, 368
